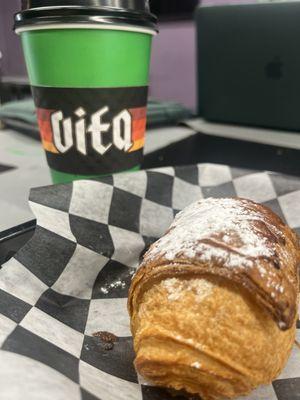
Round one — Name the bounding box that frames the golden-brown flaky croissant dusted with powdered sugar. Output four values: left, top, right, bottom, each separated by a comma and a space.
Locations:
128, 198, 300, 400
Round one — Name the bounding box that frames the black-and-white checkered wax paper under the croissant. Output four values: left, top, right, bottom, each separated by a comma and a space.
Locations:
0, 164, 300, 400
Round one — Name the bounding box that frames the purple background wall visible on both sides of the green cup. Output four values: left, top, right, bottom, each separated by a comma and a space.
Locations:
0, 0, 196, 108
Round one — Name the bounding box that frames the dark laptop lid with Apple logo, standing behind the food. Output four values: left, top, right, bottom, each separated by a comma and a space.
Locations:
196, 2, 300, 130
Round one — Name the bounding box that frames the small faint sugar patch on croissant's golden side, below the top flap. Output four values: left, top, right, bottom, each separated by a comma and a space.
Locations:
162, 278, 214, 302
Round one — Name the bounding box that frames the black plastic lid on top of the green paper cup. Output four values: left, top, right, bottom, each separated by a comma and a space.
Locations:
14, 0, 157, 31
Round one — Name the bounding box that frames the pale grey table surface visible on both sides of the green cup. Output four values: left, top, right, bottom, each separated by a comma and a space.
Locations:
0, 119, 300, 232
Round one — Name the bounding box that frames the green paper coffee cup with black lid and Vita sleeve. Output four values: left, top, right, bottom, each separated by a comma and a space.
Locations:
15, 0, 156, 183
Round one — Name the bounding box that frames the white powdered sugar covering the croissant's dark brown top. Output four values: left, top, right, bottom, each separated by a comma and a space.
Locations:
146, 198, 278, 275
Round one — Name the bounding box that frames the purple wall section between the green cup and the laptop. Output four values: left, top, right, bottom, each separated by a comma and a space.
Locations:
150, 21, 196, 108
